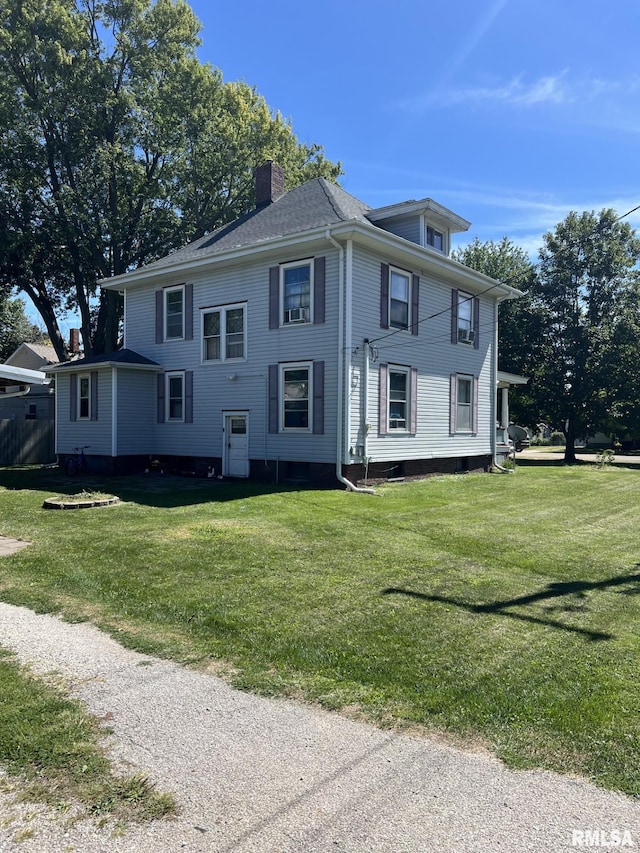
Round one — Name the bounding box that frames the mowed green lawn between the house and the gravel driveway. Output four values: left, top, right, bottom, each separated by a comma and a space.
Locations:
0, 464, 640, 796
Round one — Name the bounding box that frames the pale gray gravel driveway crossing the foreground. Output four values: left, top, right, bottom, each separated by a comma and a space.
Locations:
0, 603, 640, 853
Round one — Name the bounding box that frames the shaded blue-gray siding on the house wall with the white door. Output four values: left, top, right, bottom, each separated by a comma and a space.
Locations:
119, 249, 339, 462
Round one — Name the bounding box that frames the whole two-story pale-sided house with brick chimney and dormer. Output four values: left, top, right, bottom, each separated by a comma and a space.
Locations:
50, 163, 520, 486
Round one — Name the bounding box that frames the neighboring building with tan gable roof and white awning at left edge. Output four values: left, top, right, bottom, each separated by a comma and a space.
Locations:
0, 343, 58, 421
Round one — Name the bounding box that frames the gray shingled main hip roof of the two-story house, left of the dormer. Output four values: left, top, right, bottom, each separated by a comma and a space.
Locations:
140, 178, 371, 269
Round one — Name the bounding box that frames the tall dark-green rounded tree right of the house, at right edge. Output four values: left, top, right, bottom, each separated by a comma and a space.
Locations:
536, 210, 640, 462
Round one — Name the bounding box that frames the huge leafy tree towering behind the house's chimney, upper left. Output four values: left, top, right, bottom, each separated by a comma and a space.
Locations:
0, 0, 341, 359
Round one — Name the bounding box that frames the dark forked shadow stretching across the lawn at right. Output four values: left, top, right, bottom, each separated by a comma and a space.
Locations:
382, 563, 640, 642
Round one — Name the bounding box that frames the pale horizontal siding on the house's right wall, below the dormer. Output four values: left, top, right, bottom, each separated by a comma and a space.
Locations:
349, 243, 495, 462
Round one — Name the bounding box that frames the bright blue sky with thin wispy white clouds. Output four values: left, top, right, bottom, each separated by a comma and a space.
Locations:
190, 0, 640, 256
